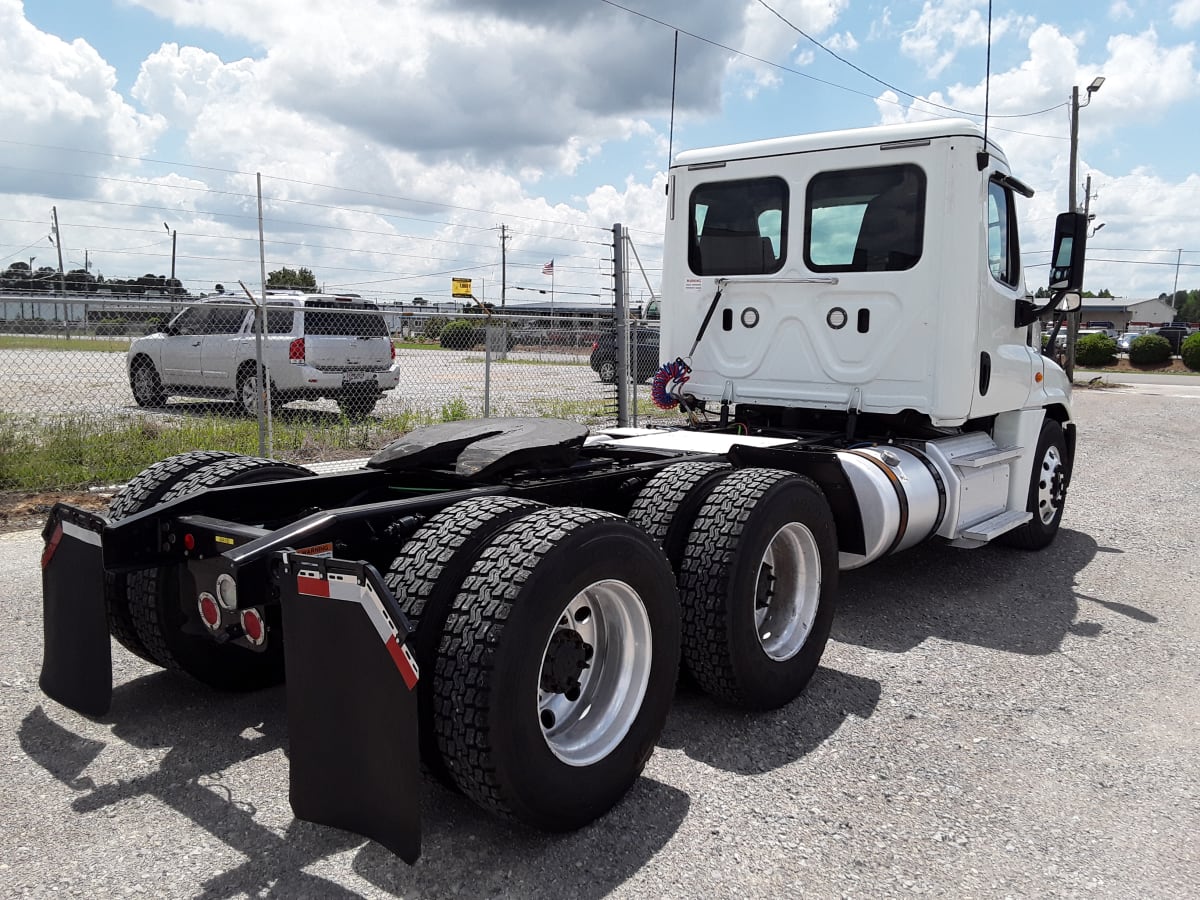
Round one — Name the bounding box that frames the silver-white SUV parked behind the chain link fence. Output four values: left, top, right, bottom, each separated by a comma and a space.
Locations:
126, 290, 400, 419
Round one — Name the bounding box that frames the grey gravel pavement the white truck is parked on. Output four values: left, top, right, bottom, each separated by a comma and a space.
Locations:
0, 386, 1200, 898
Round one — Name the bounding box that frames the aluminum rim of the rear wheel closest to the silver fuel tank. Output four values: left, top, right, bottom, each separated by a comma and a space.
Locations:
754, 522, 821, 662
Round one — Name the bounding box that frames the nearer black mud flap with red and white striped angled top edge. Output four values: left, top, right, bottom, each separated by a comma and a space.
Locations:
272, 552, 421, 863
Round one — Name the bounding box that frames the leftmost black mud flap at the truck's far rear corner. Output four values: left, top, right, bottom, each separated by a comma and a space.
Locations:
38, 503, 113, 716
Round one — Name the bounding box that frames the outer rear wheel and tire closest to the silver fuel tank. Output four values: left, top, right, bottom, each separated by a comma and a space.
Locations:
679, 468, 838, 709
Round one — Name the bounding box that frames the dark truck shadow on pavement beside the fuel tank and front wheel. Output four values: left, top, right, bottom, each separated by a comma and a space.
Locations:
833, 529, 1157, 655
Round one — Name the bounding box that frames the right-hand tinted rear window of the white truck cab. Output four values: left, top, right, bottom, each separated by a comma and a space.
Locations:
804, 164, 925, 272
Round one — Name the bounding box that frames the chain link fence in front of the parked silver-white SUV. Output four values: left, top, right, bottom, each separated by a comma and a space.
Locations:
0, 292, 674, 493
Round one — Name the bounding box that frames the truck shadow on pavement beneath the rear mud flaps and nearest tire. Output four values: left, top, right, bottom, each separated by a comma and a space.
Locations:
18, 672, 690, 898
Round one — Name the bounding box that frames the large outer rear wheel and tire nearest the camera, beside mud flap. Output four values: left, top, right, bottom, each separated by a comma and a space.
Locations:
433, 508, 679, 830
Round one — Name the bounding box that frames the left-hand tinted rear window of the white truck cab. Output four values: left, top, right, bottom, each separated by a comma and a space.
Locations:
688, 178, 787, 275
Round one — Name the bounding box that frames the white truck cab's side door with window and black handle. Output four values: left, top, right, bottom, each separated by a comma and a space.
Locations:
971, 178, 1040, 416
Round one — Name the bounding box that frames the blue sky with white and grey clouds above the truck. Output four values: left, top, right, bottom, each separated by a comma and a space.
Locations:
0, 0, 1200, 305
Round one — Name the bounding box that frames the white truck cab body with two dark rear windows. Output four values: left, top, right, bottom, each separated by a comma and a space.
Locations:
662, 120, 1069, 426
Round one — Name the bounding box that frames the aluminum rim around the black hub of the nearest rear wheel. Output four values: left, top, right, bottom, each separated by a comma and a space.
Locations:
538, 580, 653, 766
